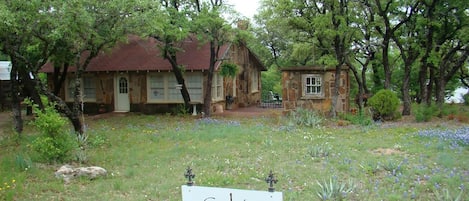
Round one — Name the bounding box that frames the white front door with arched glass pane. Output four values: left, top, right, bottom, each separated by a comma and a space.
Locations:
115, 74, 130, 112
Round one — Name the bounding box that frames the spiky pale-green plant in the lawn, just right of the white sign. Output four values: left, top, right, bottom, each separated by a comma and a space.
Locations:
316, 176, 355, 200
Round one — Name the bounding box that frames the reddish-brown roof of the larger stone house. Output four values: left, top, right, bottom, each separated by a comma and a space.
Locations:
42, 36, 229, 72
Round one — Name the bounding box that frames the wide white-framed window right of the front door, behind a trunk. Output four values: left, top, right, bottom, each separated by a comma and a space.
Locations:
147, 72, 202, 103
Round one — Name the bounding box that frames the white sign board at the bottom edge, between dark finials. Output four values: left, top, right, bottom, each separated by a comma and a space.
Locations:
181, 185, 283, 201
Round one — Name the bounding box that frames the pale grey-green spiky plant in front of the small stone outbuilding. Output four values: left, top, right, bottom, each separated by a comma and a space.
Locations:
288, 108, 323, 127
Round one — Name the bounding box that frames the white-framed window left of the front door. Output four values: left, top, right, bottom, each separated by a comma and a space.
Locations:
65, 76, 96, 102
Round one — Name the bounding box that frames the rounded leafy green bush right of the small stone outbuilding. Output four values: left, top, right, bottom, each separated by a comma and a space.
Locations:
368, 89, 399, 120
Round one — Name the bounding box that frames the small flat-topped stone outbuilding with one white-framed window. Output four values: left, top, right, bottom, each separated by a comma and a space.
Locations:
282, 66, 350, 113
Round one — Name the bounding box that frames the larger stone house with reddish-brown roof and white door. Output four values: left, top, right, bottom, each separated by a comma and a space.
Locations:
42, 36, 266, 114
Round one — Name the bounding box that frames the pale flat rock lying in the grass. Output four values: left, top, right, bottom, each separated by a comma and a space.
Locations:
55, 165, 107, 183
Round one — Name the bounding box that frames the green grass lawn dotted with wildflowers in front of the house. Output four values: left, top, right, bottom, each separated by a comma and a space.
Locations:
0, 109, 469, 201
